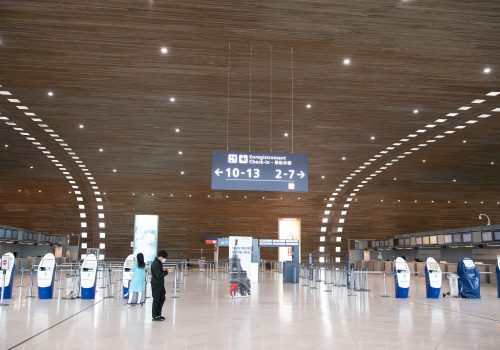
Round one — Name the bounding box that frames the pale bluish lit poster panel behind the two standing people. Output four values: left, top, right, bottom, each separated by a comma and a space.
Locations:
134, 215, 158, 262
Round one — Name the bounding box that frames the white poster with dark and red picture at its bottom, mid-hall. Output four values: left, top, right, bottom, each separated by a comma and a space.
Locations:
229, 236, 252, 298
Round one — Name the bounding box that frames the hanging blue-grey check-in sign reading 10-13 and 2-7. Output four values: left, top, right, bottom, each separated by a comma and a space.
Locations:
212, 151, 308, 192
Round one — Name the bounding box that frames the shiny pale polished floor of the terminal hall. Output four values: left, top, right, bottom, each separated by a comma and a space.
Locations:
0, 271, 500, 350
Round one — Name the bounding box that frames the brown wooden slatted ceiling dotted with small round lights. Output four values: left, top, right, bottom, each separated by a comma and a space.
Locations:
0, 0, 500, 257
